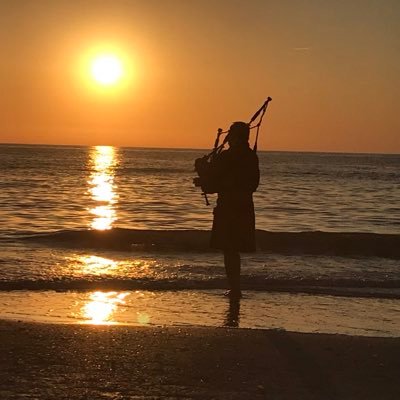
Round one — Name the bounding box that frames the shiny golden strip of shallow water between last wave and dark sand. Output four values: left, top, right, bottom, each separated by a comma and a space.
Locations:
0, 290, 400, 336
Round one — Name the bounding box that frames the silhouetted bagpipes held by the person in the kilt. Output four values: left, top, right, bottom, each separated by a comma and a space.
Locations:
193, 97, 272, 206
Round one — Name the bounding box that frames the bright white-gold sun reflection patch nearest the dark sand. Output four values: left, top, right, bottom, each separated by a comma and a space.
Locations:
82, 291, 129, 325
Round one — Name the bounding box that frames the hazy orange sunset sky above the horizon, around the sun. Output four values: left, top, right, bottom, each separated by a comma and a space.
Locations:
0, 0, 400, 153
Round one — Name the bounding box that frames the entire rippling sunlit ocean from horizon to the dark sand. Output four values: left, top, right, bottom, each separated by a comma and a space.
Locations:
0, 144, 400, 336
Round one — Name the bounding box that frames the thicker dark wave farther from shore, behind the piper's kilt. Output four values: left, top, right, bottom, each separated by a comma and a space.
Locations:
19, 228, 400, 259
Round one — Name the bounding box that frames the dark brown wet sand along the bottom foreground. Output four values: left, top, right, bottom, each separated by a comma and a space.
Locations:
0, 321, 400, 400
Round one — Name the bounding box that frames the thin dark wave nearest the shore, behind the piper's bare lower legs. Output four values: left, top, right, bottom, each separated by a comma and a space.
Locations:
0, 276, 400, 299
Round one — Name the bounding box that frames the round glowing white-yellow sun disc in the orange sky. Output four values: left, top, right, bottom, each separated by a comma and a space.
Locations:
91, 54, 124, 86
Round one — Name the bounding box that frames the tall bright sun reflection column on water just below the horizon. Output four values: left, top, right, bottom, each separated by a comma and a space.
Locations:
88, 146, 118, 230
